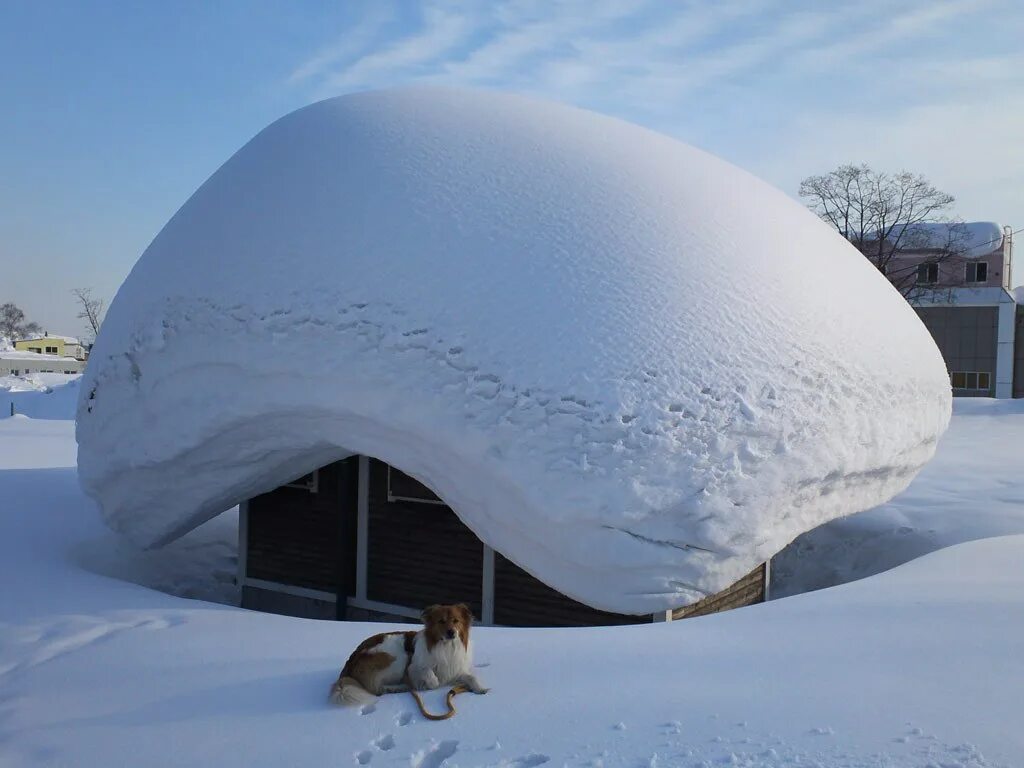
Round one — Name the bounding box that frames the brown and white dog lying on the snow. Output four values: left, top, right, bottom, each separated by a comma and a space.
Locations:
331, 603, 487, 705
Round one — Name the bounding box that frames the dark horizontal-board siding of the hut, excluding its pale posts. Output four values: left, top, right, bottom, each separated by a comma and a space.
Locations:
241, 457, 765, 627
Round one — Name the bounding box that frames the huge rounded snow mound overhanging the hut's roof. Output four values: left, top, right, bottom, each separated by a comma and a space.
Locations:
77, 89, 950, 613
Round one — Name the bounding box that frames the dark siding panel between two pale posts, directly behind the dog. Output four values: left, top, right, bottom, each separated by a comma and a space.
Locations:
367, 459, 483, 616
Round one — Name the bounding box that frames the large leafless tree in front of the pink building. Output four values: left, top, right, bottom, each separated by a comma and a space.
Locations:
800, 164, 968, 301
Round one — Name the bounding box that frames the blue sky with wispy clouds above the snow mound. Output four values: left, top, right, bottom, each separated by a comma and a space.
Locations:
0, 0, 1024, 333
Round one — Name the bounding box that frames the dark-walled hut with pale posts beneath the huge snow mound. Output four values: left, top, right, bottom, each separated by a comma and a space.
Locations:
239, 456, 770, 627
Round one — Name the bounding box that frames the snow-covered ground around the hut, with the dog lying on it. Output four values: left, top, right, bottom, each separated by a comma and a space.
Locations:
0, 400, 1024, 768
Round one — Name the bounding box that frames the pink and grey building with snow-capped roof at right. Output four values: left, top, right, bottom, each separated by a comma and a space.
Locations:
888, 221, 1024, 397
